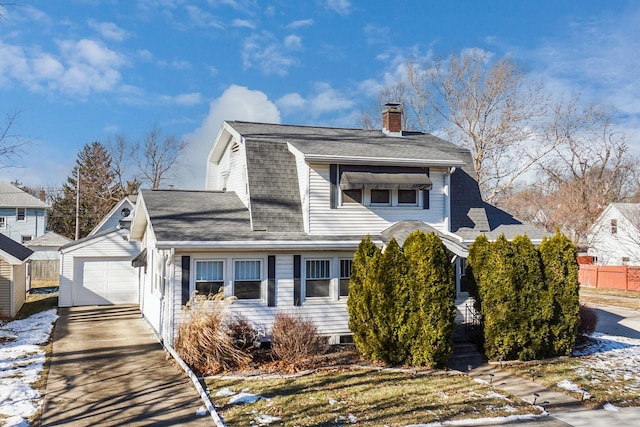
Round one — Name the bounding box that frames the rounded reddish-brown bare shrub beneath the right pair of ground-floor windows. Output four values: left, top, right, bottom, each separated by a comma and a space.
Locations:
271, 313, 326, 368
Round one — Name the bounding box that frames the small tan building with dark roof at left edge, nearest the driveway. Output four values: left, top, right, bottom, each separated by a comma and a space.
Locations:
0, 234, 33, 317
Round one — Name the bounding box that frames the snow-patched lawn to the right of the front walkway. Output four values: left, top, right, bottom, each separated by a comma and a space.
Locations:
505, 356, 640, 407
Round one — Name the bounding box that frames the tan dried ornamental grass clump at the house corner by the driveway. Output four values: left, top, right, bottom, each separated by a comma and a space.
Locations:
174, 294, 251, 375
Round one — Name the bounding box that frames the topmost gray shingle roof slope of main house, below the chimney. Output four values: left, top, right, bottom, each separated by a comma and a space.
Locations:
227, 121, 467, 166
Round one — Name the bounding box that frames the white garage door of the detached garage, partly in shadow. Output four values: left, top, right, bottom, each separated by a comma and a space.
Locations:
73, 259, 138, 305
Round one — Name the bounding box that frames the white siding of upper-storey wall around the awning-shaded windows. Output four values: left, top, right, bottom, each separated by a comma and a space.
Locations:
303, 164, 445, 235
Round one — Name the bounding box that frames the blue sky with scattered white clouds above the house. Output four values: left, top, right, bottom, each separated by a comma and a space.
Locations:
0, 0, 640, 188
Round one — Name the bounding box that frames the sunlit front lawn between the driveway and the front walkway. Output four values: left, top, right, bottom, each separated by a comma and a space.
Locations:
206, 369, 540, 427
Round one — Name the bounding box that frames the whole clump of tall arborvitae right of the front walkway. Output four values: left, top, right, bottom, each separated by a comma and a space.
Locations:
468, 233, 580, 360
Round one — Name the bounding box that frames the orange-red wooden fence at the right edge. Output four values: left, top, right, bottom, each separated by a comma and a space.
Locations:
578, 264, 640, 291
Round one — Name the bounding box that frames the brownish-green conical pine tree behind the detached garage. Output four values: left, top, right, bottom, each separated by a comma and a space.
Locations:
49, 142, 125, 238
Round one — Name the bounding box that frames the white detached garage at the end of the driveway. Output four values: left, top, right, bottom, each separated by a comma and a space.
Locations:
58, 228, 140, 307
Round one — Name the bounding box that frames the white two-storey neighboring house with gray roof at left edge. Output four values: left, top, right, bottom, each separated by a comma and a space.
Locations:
0, 182, 49, 243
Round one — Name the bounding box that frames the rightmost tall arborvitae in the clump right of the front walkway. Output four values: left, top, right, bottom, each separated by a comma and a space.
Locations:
539, 231, 580, 355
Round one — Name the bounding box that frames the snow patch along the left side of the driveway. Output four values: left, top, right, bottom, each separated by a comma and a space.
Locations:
0, 310, 58, 426
